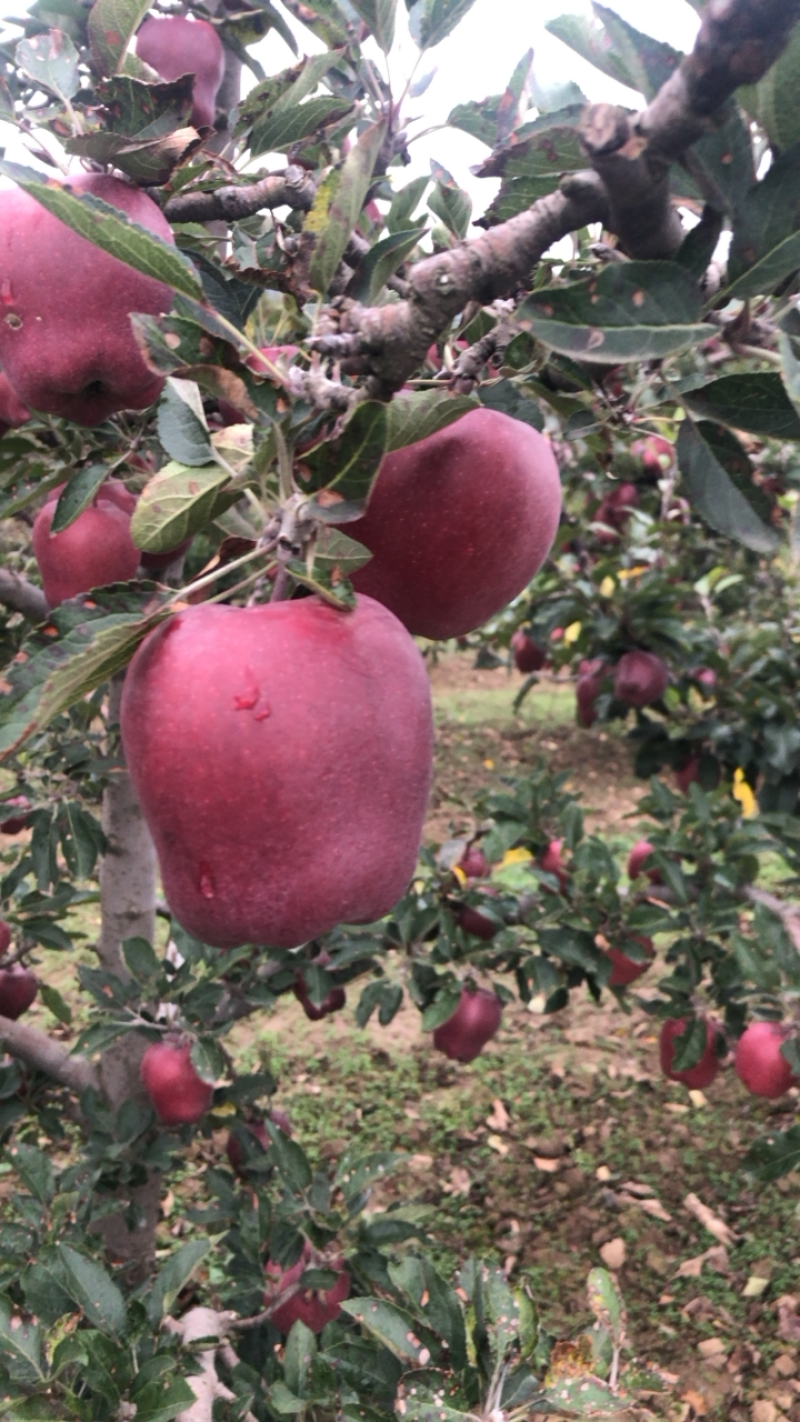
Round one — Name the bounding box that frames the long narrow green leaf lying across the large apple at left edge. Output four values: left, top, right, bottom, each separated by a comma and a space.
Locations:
0, 159, 203, 301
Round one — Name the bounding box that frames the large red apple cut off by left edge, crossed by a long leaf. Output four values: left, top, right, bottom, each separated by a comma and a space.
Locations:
0, 173, 173, 425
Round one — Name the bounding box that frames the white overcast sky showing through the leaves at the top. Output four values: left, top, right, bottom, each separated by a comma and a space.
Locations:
0, 0, 699, 216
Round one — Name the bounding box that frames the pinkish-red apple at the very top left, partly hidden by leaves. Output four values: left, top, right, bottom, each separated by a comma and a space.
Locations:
136, 14, 225, 128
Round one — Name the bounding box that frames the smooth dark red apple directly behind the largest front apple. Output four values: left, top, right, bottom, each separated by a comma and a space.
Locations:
348, 409, 561, 637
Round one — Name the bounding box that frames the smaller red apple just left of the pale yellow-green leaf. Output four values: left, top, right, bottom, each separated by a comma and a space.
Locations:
31, 488, 139, 607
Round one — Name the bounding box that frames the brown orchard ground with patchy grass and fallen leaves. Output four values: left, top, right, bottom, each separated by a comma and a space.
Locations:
6, 654, 800, 1422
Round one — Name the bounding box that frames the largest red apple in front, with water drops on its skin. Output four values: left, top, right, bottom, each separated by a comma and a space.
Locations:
121, 597, 433, 947
